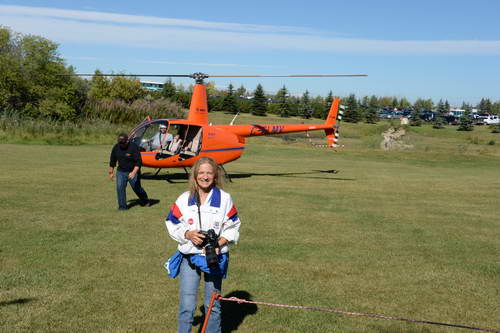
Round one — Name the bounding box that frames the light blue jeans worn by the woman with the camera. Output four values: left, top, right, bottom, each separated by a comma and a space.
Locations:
179, 258, 222, 333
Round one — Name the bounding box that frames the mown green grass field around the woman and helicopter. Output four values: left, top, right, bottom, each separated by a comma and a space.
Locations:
0, 114, 500, 333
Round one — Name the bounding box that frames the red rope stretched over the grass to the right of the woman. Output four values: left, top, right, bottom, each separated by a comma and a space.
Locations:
217, 295, 500, 333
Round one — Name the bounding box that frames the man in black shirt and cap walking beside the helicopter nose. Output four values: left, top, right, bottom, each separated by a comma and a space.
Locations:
109, 134, 150, 210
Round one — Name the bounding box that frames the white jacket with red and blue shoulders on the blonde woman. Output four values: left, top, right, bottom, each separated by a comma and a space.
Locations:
165, 187, 240, 254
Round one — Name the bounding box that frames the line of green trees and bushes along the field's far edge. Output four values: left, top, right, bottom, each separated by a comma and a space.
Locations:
0, 26, 500, 128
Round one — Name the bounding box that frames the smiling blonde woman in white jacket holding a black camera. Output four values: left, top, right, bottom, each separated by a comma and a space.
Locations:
165, 157, 240, 333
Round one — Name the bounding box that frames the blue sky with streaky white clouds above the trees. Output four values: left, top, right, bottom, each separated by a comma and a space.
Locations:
0, 0, 500, 105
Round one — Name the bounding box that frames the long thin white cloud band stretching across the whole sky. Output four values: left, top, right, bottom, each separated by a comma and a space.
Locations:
0, 5, 500, 55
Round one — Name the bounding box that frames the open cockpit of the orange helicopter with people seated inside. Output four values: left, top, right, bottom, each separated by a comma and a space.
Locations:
130, 120, 202, 160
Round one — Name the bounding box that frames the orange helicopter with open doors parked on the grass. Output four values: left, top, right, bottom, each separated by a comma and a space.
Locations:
80, 73, 366, 174
